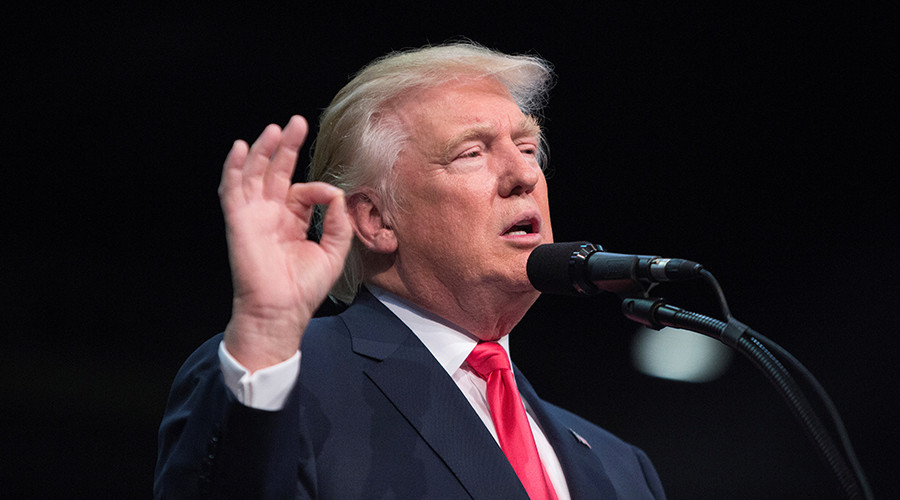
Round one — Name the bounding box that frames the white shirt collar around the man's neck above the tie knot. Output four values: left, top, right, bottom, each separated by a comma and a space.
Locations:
366, 284, 509, 376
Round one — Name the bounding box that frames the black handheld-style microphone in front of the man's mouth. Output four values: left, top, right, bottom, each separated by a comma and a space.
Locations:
526, 241, 703, 295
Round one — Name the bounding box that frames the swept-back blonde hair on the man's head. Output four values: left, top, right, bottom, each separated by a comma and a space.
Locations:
308, 41, 553, 303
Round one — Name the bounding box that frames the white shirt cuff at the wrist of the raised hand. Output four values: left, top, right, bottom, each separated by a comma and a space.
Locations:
219, 341, 300, 411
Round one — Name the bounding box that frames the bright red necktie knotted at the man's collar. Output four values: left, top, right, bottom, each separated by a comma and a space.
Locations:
466, 342, 556, 500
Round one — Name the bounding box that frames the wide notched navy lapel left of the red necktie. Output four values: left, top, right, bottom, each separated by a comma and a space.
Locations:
341, 291, 528, 499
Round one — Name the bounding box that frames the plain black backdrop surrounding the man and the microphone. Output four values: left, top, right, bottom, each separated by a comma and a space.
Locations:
0, 2, 900, 498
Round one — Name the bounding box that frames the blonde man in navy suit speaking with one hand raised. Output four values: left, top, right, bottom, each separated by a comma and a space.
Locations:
154, 43, 664, 499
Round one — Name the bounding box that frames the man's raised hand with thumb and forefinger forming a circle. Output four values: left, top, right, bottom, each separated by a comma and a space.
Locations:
219, 116, 353, 371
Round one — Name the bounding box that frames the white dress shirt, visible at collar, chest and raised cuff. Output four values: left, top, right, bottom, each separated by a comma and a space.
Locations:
219, 286, 570, 500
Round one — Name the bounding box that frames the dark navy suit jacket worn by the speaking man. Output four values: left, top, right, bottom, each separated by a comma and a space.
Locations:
154, 291, 664, 499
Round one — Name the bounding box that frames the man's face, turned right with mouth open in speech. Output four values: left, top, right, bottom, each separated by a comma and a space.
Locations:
384, 78, 553, 301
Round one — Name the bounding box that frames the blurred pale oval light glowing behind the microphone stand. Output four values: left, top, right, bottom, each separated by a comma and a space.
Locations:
631, 327, 732, 382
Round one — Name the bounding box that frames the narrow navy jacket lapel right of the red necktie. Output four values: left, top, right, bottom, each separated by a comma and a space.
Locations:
513, 367, 618, 500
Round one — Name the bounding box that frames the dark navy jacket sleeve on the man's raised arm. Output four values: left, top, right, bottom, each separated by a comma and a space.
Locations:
153, 334, 315, 499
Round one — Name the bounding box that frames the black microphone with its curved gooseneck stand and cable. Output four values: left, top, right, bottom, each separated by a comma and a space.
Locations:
526, 241, 872, 499
